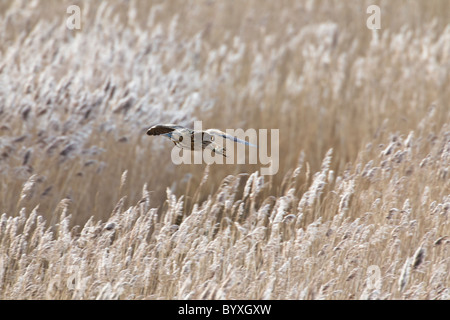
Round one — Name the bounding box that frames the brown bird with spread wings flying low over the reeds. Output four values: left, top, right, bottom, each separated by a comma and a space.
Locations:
147, 124, 256, 157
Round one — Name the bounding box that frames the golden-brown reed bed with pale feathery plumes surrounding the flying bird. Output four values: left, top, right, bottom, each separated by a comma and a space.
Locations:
0, 0, 450, 299
